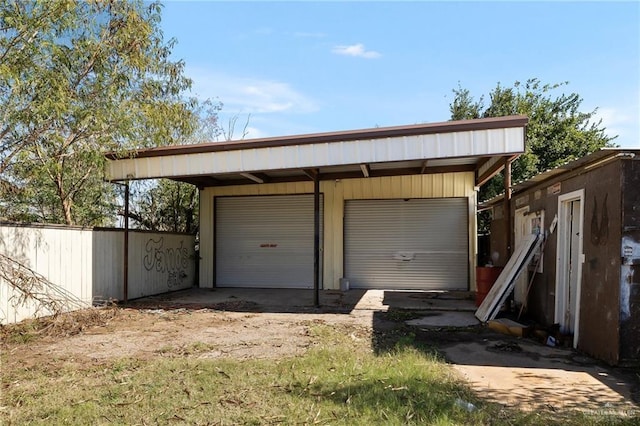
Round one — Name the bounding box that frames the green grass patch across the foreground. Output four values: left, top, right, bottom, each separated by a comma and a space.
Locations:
0, 323, 632, 425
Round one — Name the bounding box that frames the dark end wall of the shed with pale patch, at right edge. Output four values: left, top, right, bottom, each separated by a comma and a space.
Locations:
619, 160, 640, 363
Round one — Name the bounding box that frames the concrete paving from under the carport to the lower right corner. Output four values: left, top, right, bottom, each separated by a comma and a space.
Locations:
128, 288, 640, 416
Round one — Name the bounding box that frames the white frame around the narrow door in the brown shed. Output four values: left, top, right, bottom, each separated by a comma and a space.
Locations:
554, 189, 584, 348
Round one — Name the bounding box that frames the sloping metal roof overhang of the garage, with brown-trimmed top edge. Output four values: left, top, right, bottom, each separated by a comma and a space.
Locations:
106, 116, 527, 188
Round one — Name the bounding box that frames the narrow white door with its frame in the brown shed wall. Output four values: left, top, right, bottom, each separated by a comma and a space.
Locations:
555, 190, 584, 347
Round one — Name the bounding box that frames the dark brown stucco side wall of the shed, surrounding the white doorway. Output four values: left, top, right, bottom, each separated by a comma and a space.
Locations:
496, 161, 622, 364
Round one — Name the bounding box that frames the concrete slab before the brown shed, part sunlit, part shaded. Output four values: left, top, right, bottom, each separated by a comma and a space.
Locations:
441, 338, 640, 416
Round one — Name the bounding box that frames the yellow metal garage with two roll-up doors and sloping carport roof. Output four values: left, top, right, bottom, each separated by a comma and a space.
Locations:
107, 116, 527, 305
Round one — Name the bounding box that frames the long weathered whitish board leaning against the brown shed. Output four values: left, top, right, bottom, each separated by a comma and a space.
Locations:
476, 234, 542, 322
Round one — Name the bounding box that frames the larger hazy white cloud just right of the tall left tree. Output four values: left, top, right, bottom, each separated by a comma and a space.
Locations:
186, 67, 318, 114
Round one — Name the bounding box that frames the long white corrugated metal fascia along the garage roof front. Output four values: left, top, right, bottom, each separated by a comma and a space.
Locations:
107, 127, 524, 180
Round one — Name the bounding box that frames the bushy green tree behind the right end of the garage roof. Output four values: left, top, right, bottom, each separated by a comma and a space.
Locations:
449, 79, 614, 208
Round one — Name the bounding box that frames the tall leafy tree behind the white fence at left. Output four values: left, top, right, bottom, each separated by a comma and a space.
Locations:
0, 0, 196, 225
